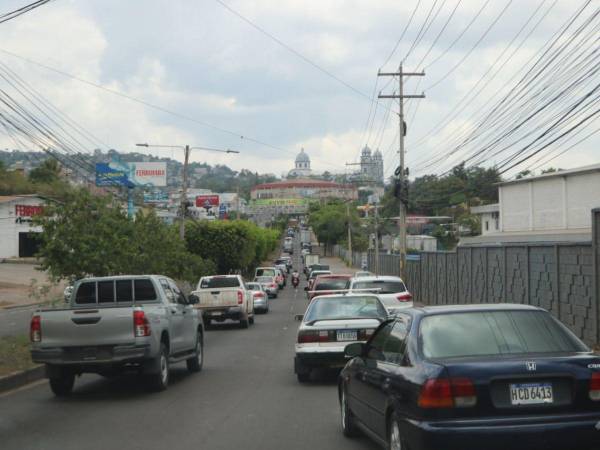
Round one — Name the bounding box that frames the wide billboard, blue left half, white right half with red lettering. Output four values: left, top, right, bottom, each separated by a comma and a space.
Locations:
96, 161, 167, 187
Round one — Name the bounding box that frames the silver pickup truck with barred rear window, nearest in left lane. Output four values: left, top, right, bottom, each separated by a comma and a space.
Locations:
30, 275, 204, 396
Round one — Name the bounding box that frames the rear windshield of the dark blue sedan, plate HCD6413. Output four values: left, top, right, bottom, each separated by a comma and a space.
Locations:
421, 311, 587, 359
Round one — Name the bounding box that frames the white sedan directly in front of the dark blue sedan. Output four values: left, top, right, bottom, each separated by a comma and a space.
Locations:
294, 294, 387, 383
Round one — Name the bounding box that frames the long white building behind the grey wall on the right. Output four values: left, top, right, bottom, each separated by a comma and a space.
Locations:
461, 164, 600, 245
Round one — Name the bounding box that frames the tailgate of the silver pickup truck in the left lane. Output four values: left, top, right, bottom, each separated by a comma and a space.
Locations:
41, 306, 135, 347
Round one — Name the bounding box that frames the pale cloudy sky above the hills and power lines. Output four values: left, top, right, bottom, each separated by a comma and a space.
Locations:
0, 0, 600, 179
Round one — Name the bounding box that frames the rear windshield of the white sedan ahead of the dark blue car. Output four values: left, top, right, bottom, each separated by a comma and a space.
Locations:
305, 296, 387, 323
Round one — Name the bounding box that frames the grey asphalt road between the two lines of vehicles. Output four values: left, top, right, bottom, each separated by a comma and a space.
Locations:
0, 246, 378, 450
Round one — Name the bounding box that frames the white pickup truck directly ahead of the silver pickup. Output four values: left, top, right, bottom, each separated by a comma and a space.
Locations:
192, 275, 254, 328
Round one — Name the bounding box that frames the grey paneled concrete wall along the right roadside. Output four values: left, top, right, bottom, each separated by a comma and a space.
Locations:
341, 208, 600, 345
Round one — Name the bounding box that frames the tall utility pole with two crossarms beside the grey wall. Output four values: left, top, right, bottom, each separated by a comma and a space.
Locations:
377, 63, 425, 277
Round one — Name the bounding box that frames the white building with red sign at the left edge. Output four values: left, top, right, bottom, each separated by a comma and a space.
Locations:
0, 195, 45, 258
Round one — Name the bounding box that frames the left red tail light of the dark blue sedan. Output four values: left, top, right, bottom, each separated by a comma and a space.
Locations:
419, 378, 477, 408
